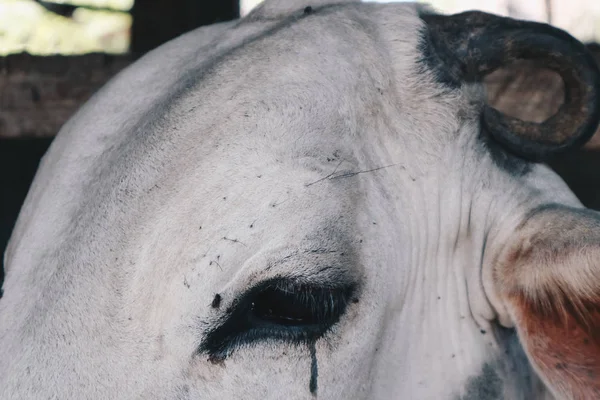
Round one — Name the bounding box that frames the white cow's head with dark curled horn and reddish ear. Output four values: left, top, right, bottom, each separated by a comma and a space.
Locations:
0, 0, 600, 400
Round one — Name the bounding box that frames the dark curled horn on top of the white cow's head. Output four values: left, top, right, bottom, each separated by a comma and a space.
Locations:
421, 11, 600, 161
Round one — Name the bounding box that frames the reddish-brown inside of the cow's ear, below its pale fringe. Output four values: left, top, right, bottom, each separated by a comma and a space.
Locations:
511, 294, 600, 400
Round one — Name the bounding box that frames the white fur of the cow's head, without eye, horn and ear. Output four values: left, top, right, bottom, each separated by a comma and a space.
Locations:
0, 1, 578, 399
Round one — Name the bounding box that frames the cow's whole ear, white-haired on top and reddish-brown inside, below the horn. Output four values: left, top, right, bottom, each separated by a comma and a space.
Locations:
493, 206, 600, 399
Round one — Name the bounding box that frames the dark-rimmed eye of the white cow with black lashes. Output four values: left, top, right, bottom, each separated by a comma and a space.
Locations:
200, 279, 356, 358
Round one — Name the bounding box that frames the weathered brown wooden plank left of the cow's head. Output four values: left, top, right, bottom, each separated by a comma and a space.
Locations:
0, 53, 133, 138
